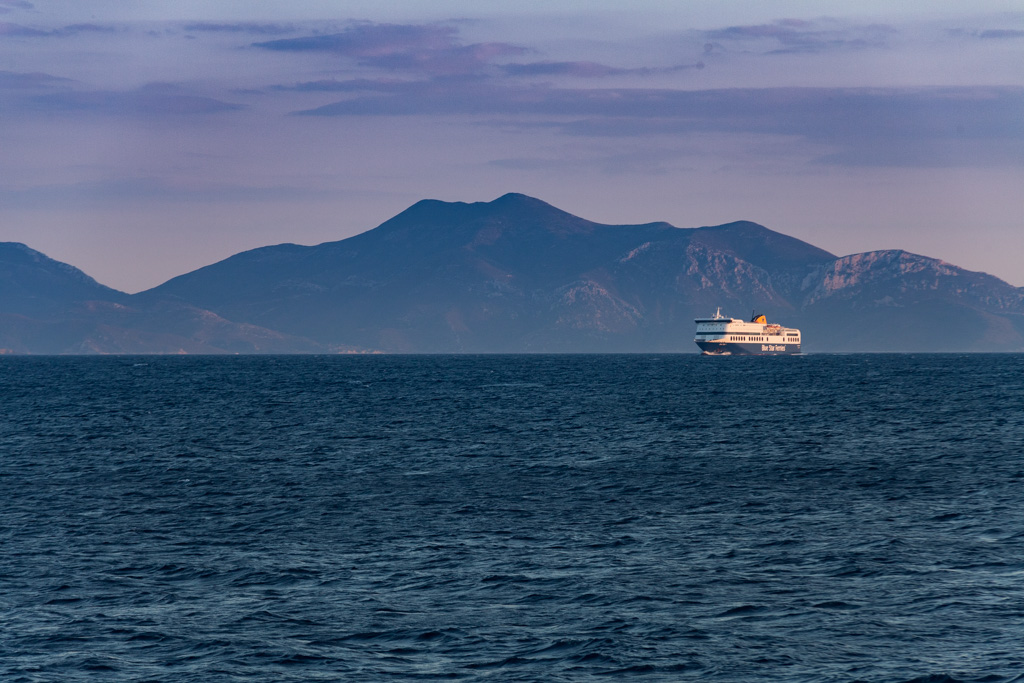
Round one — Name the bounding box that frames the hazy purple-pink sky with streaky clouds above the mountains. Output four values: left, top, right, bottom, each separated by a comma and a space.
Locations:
0, 0, 1024, 292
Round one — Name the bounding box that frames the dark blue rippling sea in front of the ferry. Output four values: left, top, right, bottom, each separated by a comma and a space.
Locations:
0, 354, 1024, 683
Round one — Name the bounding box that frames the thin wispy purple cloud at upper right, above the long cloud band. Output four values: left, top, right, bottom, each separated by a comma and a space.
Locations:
703, 19, 898, 54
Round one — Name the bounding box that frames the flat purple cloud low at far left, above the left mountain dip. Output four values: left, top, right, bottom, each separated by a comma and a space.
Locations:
32, 83, 243, 116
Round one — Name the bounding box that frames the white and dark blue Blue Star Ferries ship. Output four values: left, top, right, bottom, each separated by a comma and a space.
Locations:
693, 307, 800, 355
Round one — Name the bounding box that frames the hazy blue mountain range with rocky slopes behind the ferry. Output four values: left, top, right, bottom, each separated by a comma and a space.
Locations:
0, 194, 1024, 353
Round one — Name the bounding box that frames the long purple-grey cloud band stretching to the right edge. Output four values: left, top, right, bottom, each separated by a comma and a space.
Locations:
296, 79, 1024, 166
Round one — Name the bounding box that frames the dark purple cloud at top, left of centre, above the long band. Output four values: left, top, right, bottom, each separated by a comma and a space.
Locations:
253, 24, 528, 75
